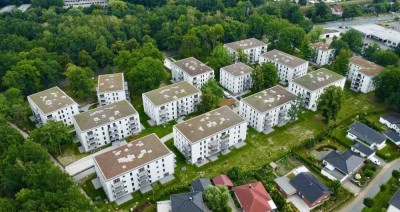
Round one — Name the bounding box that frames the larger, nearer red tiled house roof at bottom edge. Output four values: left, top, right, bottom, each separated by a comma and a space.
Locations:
233, 182, 272, 212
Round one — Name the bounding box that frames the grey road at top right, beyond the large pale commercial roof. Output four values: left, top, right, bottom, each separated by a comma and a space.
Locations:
318, 14, 393, 28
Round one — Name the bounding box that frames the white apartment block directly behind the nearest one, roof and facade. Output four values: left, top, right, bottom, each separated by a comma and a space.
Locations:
74, 100, 141, 152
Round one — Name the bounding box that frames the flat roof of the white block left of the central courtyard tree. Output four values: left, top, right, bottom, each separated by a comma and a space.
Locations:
143, 81, 200, 106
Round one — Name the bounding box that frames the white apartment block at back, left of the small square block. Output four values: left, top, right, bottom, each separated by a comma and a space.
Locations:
171, 57, 214, 89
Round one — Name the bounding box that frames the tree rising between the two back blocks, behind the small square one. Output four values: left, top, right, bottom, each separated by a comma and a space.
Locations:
208, 45, 233, 80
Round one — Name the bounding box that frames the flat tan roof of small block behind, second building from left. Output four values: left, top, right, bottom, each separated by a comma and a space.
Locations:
97, 73, 125, 93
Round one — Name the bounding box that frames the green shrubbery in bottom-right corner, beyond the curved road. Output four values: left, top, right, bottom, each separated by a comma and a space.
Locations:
362, 177, 400, 212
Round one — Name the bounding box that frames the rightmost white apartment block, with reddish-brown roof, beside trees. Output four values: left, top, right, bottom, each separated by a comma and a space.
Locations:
347, 56, 384, 93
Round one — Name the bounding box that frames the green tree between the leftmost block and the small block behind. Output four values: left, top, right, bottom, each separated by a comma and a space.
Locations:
65, 64, 94, 99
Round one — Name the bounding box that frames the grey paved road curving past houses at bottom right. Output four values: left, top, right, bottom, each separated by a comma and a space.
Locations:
340, 159, 400, 212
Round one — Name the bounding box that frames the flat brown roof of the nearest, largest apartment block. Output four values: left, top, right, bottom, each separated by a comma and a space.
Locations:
94, 133, 172, 180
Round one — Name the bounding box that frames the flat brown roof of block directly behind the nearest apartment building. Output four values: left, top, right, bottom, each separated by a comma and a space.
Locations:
74, 100, 137, 131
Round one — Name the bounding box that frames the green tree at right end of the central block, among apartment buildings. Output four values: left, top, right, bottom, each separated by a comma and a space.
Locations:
198, 80, 224, 113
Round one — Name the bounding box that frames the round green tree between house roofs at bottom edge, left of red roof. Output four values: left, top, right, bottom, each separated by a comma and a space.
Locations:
204, 185, 230, 212
